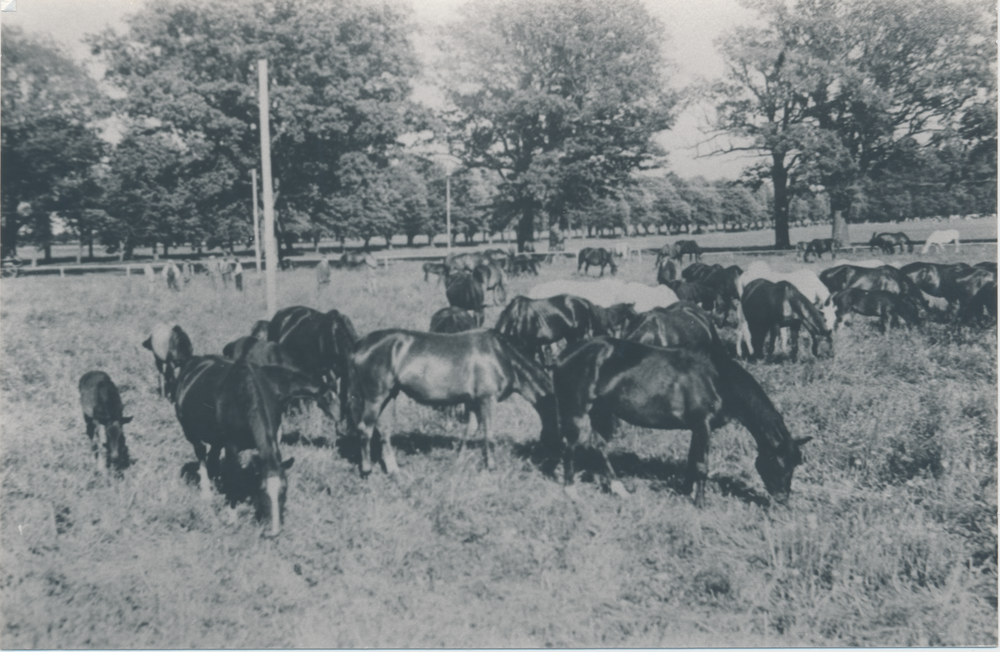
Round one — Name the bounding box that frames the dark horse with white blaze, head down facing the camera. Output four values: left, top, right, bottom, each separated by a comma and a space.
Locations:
175, 356, 332, 537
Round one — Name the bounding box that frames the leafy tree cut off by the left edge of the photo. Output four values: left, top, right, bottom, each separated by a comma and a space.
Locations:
0, 25, 105, 258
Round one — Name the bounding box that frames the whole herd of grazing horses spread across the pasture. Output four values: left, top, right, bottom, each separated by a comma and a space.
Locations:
80, 231, 997, 536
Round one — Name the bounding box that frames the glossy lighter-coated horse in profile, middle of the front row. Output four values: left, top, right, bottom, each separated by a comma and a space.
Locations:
348, 329, 556, 476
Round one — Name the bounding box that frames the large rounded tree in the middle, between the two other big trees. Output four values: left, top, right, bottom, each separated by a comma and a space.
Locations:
448, 0, 677, 249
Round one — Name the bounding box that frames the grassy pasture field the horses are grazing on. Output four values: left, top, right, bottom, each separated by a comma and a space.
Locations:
0, 243, 997, 649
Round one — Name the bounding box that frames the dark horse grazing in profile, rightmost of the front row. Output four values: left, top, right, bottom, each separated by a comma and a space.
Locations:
542, 337, 811, 507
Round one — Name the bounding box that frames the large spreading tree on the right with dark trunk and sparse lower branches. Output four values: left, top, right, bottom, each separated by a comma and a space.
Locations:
715, 0, 996, 247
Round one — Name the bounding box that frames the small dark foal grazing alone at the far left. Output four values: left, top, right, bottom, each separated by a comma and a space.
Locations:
79, 371, 132, 470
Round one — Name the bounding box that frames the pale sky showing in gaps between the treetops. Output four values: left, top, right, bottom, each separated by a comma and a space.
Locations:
0, 0, 753, 179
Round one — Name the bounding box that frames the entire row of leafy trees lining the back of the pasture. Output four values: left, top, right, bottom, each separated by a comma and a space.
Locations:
0, 0, 996, 256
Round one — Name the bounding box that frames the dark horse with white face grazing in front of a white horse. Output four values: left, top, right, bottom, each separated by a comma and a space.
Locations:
743, 278, 836, 361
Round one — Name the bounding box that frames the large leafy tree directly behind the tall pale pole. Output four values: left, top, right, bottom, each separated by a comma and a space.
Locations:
92, 0, 416, 253
